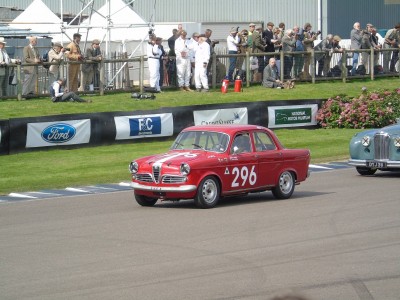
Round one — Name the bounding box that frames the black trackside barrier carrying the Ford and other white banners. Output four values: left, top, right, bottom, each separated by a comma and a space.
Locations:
0, 99, 322, 155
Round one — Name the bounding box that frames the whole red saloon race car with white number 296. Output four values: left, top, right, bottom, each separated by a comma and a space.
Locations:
129, 125, 310, 208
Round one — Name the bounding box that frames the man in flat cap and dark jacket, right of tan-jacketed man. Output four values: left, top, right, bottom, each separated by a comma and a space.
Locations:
79, 39, 103, 91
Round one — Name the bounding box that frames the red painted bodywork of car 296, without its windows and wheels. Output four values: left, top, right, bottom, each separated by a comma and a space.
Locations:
132, 125, 310, 200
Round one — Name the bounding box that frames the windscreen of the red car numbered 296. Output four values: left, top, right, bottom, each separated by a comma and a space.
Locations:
171, 131, 229, 153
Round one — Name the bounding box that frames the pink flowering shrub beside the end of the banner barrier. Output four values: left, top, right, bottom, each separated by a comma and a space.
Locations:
317, 87, 400, 129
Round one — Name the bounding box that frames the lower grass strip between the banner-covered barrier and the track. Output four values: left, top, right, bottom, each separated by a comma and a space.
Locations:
0, 129, 359, 195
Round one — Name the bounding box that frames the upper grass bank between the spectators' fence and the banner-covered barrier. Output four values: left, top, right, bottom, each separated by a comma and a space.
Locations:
0, 77, 400, 120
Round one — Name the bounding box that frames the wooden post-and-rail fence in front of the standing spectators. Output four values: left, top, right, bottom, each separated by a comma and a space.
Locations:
2, 48, 400, 100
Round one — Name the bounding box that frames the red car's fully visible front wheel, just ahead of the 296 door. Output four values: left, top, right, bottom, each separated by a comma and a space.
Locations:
194, 176, 220, 208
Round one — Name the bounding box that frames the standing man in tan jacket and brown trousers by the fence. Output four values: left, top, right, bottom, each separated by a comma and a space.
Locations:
67, 33, 84, 92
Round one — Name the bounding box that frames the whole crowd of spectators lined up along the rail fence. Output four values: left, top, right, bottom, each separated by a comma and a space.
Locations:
0, 18, 400, 98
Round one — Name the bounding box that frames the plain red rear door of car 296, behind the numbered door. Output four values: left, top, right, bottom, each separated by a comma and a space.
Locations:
253, 131, 283, 187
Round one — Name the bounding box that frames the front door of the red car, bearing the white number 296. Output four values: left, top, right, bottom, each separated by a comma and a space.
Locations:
223, 132, 258, 193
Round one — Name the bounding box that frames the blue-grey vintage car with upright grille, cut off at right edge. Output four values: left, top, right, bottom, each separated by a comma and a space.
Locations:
348, 124, 400, 175
